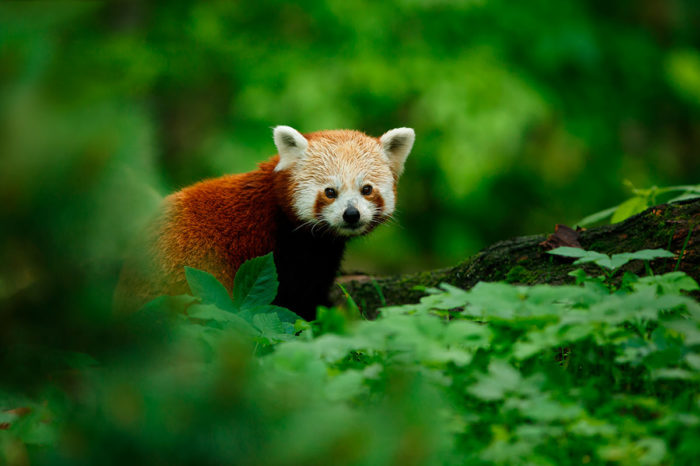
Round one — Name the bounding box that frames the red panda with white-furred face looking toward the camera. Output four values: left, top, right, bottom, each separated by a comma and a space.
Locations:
116, 126, 415, 320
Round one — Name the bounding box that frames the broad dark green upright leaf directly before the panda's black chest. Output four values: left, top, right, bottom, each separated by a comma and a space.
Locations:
233, 253, 278, 310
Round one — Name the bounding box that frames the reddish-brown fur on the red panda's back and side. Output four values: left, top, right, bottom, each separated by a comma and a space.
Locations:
116, 156, 294, 310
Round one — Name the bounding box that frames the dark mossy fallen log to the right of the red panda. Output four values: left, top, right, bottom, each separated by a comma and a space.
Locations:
331, 199, 700, 318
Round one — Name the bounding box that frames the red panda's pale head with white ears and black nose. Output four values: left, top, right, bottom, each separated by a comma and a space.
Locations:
274, 126, 415, 236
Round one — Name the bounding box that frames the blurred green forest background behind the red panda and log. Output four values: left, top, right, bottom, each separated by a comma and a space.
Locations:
0, 0, 700, 312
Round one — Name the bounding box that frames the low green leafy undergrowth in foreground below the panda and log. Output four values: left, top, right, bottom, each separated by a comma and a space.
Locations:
0, 248, 700, 465
